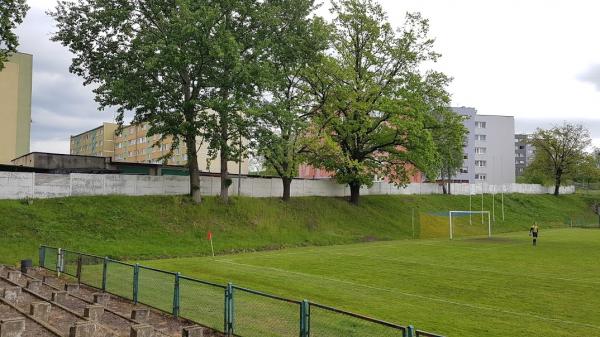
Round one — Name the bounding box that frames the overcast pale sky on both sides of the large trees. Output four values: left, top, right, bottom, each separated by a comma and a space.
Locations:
18, 0, 600, 153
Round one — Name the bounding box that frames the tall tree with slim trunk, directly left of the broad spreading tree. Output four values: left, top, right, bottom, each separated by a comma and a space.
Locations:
254, 0, 328, 201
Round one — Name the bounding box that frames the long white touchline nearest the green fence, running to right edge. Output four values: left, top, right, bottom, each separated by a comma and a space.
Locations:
220, 259, 600, 330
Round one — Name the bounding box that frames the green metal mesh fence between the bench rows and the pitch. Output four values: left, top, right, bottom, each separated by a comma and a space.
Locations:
39, 246, 443, 337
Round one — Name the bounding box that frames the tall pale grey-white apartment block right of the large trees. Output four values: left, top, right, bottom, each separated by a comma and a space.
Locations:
452, 107, 515, 185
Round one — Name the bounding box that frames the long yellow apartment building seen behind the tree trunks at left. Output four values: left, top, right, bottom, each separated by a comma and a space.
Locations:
71, 123, 248, 174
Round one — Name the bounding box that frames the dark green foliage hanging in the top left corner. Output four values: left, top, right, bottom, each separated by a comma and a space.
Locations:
0, 0, 29, 71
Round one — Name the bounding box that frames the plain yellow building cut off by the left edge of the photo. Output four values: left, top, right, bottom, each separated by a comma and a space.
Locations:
0, 53, 33, 164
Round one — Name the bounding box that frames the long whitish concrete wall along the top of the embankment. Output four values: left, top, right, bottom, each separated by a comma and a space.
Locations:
0, 172, 575, 199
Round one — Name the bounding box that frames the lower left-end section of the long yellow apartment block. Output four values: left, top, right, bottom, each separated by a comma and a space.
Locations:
71, 123, 117, 157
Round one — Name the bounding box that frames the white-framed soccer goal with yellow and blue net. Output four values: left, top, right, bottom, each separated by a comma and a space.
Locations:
419, 210, 492, 239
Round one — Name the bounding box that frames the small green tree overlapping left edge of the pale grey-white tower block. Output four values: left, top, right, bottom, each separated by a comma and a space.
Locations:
432, 109, 468, 194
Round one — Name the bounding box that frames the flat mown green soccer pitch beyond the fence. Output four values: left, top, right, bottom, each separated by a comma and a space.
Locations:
143, 229, 600, 337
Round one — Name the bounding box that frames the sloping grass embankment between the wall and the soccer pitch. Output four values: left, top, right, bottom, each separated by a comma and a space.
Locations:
0, 195, 598, 263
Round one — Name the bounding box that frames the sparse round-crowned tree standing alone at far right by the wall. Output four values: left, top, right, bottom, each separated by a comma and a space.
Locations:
526, 123, 592, 195
